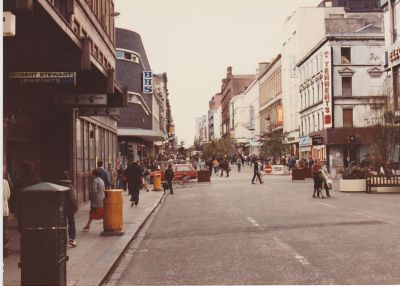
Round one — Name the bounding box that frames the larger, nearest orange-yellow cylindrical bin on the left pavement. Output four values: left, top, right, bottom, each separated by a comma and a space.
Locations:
101, 189, 124, 235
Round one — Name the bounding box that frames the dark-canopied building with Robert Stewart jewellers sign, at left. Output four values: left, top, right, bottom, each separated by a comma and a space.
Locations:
3, 0, 126, 206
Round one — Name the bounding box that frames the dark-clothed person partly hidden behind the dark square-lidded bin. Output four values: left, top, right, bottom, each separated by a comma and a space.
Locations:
58, 171, 78, 247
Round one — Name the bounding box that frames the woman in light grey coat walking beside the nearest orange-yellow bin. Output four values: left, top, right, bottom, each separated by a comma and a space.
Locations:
83, 169, 105, 231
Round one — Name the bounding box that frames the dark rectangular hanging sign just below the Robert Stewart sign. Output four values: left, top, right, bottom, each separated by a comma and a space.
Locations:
55, 94, 107, 106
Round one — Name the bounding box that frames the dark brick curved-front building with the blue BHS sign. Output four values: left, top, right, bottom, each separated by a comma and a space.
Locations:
116, 28, 165, 165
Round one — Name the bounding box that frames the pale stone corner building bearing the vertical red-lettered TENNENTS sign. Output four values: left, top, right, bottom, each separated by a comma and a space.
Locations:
297, 13, 386, 169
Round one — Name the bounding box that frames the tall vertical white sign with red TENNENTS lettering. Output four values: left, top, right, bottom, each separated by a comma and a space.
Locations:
322, 47, 332, 128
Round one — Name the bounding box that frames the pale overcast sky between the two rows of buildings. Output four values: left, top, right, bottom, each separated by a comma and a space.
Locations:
115, 0, 321, 147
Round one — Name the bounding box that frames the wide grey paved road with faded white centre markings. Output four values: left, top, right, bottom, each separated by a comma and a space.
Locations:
108, 167, 400, 285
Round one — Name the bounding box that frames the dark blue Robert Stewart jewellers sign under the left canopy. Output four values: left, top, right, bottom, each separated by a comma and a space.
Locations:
8, 72, 76, 85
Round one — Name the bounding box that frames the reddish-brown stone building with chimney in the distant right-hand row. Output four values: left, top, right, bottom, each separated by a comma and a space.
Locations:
221, 67, 255, 137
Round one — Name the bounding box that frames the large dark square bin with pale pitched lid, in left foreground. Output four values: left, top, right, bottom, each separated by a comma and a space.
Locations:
18, 182, 69, 285
